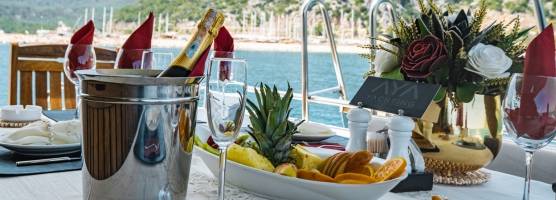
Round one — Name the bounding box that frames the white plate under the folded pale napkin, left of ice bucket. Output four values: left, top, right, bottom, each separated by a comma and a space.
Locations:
0, 142, 81, 156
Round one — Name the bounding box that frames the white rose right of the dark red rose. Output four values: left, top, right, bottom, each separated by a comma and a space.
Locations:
465, 43, 512, 79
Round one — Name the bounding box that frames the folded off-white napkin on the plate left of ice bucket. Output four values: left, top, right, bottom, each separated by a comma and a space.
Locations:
2, 120, 81, 145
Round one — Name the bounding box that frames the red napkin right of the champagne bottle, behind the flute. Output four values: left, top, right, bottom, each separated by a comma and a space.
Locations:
189, 26, 234, 76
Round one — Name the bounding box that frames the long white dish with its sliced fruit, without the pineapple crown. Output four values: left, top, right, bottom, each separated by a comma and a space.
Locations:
194, 126, 407, 200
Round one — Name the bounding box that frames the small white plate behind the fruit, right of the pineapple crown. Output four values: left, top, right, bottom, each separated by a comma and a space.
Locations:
293, 122, 336, 141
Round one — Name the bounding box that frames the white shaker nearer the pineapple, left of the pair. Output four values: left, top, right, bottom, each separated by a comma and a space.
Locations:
346, 102, 371, 152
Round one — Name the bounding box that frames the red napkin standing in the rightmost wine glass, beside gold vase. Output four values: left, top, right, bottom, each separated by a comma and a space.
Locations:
506, 25, 556, 139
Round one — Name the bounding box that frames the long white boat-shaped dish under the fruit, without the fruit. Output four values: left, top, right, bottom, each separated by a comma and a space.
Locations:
194, 146, 407, 200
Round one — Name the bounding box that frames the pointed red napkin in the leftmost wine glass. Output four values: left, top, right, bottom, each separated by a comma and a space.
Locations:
68, 20, 95, 72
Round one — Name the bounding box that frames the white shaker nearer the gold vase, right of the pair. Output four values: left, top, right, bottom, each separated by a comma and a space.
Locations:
387, 110, 415, 173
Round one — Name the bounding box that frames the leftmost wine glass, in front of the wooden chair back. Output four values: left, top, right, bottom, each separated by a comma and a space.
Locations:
64, 44, 97, 119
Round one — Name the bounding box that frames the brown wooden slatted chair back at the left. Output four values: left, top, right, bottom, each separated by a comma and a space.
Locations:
8, 43, 116, 110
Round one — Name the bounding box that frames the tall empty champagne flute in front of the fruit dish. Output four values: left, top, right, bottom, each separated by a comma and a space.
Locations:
205, 52, 247, 200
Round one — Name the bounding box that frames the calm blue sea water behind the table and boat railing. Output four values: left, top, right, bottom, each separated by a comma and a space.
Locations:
0, 44, 368, 126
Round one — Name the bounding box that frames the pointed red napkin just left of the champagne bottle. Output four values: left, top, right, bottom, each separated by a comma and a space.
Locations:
118, 12, 154, 69
